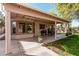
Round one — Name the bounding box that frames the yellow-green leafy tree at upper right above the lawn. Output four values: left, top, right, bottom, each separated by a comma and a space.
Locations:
57, 3, 79, 20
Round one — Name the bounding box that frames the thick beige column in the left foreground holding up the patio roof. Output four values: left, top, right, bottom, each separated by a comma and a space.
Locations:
5, 10, 11, 54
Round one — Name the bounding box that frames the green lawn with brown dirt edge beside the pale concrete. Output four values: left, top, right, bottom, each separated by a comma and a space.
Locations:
45, 35, 79, 56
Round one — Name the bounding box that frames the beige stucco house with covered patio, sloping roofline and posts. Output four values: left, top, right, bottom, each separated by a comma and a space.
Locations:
3, 3, 68, 54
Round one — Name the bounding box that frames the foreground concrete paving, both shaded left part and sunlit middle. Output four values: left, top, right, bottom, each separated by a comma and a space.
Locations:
0, 40, 58, 56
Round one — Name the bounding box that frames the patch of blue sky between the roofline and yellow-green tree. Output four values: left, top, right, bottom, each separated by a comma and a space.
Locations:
29, 3, 56, 13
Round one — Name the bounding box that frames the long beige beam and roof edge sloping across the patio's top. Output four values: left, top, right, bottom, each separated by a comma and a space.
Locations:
3, 3, 68, 23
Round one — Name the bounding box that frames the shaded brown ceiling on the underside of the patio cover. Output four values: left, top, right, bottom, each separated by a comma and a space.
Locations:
11, 13, 54, 23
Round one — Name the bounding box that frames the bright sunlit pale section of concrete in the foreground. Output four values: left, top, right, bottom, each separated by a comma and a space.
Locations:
17, 41, 58, 56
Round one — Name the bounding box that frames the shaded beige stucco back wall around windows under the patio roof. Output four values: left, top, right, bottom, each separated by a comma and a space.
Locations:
12, 21, 53, 39
